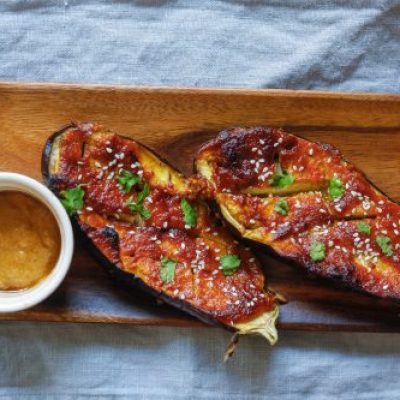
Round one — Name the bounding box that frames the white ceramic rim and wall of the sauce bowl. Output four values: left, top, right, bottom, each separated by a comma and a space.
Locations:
0, 172, 74, 312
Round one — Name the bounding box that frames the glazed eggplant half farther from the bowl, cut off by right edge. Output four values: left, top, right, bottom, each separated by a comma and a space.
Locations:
195, 127, 400, 300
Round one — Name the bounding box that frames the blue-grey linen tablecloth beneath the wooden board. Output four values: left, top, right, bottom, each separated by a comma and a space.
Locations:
0, 0, 400, 400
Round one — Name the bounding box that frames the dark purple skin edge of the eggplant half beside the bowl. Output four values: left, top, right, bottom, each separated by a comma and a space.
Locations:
41, 122, 230, 332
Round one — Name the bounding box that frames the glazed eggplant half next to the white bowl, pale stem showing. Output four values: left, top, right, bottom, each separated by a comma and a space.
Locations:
42, 124, 278, 344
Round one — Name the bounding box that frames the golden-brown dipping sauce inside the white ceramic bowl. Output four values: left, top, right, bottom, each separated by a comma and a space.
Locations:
0, 191, 61, 290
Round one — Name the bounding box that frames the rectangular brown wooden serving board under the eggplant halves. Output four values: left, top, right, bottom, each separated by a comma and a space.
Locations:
0, 83, 400, 332
